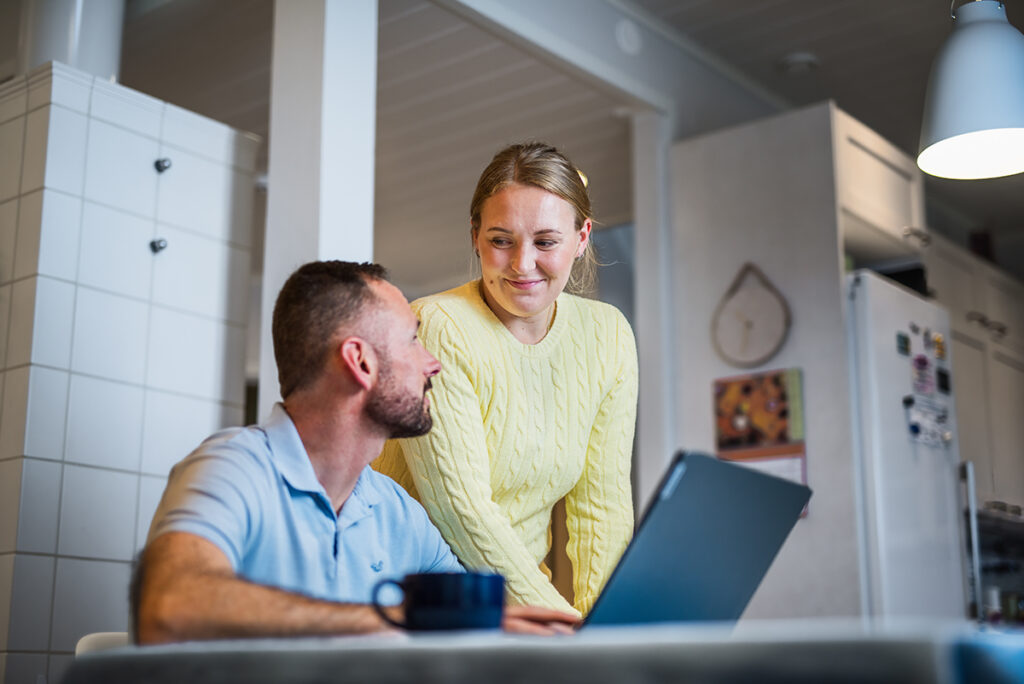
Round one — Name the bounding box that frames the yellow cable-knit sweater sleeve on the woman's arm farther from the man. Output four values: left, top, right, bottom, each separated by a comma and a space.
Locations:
565, 312, 638, 614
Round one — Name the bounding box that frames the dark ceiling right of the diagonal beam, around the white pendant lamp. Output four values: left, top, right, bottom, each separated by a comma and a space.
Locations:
631, 0, 1024, 279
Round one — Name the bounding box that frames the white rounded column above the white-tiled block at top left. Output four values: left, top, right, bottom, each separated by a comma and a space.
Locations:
16, 0, 125, 82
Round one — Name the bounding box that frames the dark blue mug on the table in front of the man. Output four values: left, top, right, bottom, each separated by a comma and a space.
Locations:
373, 572, 505, 632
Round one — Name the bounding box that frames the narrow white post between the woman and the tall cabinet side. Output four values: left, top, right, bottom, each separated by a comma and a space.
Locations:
633, 112, 685, 510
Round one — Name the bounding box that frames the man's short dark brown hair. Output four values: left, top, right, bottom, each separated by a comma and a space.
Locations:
271, 261, 387, 398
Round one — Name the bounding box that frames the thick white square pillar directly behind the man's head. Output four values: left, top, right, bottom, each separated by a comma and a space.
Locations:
259, 0, 377, 418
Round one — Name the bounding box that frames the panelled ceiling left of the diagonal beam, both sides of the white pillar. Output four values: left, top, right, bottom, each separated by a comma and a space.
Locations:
121, 0, 633, 297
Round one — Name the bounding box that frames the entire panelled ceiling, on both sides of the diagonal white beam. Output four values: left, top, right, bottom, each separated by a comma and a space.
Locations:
121, 0, 1024, 295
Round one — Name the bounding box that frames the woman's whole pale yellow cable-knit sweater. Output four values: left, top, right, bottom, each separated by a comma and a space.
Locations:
374, 281, 637, 614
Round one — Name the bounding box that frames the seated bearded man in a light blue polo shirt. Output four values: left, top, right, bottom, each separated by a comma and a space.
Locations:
132, 261, 573, 643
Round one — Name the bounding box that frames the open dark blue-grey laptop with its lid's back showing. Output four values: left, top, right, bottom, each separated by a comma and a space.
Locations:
584, 452, 811, 627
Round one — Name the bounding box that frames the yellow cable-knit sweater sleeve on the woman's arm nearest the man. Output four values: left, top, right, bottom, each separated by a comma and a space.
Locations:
400, 312, 575, 613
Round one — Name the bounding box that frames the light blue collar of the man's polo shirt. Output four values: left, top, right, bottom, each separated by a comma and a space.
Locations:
261, 401, 381, 523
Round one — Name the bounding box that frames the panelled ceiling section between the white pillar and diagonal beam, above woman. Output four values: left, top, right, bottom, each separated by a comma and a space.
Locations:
374, 0, 633, 294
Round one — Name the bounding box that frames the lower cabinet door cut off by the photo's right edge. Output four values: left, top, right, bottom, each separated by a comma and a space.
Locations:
988, 348, 1024, 505
